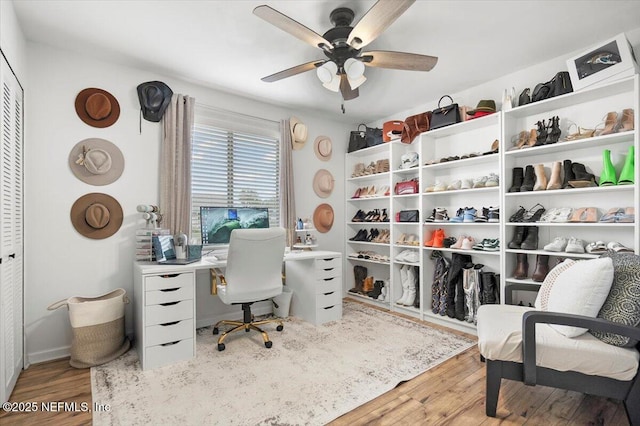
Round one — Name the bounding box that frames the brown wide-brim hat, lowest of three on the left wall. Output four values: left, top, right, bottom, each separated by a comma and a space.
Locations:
71, 192, 123, 240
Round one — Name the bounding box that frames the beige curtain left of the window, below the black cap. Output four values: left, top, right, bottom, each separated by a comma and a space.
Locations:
160, 94, 195, 236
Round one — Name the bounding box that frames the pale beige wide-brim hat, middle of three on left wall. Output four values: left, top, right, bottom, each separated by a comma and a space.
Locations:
69, 138, 124, 186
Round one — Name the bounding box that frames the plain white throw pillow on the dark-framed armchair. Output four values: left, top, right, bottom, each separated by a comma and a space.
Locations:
547, 257, 613, 337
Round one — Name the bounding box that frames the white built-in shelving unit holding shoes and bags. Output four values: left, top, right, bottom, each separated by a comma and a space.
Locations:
344, 75, 640, 332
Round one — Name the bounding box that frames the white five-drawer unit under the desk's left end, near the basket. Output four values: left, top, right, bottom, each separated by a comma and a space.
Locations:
134, 271, 196, 370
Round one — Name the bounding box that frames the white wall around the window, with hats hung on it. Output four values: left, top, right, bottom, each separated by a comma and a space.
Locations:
25, 42, 351, 362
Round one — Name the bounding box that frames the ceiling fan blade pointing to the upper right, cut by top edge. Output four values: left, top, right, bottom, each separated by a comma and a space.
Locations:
347, 0, 415, 49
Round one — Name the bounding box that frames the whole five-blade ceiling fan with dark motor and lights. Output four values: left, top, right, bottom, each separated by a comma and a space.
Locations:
253, 0, 438, 100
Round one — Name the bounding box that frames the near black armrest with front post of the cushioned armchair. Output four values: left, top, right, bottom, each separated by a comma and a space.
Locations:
522, 311, 640, 386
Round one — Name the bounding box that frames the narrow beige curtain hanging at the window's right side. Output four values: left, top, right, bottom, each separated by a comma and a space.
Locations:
280, 119, 296, 247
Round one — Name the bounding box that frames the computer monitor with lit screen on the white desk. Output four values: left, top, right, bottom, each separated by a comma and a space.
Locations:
200, 206, 269, 245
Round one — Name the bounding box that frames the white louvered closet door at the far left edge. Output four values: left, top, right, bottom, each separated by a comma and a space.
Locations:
0, 51, 24, 402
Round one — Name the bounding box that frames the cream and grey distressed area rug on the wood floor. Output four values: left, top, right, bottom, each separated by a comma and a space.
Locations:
91, 301, 475, 426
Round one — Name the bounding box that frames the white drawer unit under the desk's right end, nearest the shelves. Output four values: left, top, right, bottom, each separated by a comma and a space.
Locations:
286, 253, 342, 325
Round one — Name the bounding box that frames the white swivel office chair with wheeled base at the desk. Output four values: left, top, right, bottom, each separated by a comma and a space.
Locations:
213, 228, 285, 351
